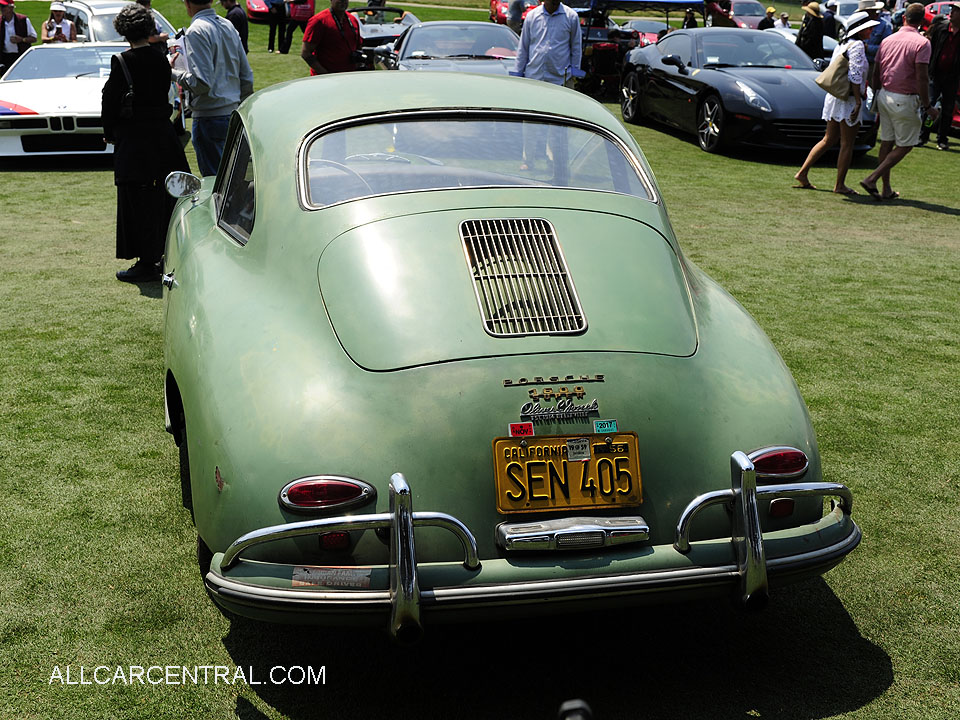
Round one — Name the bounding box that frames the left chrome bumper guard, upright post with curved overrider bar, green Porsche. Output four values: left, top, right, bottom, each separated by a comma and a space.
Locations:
220, 473, 480, 641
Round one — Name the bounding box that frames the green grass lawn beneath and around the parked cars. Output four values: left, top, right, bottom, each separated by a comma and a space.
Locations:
0, 0, 960, 720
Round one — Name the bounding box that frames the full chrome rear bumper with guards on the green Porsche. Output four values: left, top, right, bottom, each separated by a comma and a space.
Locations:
206, 452, 861, 640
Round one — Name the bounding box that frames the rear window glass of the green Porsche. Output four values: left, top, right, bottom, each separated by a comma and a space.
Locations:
303, 115, 654, 208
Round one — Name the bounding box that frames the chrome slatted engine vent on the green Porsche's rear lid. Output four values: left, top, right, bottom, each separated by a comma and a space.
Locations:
460, 219, 587, 337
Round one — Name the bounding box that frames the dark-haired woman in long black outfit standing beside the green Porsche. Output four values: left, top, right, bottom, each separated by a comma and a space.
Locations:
101, 5, 190, 282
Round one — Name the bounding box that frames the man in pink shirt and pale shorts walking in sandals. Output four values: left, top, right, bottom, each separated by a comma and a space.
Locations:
860, 3, 936, 200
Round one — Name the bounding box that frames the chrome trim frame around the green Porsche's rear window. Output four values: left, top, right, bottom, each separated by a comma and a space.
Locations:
298, 107, 660, 211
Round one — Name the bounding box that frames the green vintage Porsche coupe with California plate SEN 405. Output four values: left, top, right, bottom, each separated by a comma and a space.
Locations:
163, 72, 860, 640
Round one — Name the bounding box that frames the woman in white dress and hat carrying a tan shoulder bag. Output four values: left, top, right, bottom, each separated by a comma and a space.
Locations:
793, 12, 880, 195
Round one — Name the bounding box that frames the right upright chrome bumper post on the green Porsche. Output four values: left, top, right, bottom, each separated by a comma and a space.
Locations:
730, 450, 770, 605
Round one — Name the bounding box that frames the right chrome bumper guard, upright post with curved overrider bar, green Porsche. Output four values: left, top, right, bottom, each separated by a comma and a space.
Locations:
673, 450, 853, 606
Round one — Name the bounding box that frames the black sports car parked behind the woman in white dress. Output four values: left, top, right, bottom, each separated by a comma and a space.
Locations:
620, 28, 877, 153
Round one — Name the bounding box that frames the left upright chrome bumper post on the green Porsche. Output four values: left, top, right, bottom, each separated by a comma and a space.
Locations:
390, 473, 422, 637
